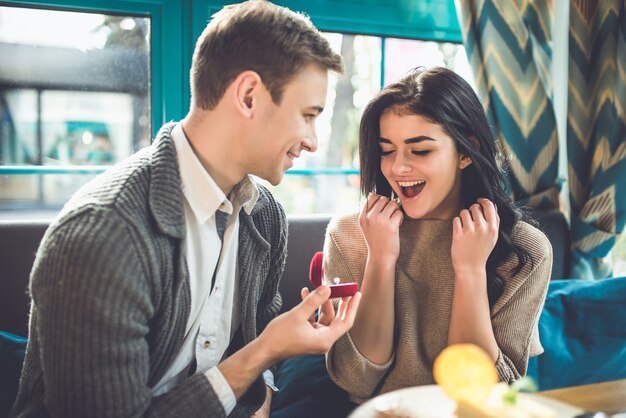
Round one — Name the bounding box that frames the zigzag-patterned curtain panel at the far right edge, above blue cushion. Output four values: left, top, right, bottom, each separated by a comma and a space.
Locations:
567, 0, 626, 278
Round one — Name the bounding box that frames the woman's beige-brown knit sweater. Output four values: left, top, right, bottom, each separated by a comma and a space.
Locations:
324, 214, 552, 402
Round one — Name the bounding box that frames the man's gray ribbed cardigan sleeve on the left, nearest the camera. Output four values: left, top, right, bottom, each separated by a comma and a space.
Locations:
25, 211, 225, 417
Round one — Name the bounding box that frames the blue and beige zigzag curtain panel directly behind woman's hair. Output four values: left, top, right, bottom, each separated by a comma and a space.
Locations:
457, 0, 560, 208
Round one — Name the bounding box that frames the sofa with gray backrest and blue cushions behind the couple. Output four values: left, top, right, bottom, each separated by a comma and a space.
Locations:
0, 210, 626, 418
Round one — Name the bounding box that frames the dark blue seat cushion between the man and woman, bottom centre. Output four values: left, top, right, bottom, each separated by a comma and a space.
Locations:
270, 355, 356, 418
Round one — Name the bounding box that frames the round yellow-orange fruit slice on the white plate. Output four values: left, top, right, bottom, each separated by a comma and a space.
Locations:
433, 344, 498, 404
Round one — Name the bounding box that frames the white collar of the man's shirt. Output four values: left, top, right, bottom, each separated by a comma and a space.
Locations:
172, 123, 259, 222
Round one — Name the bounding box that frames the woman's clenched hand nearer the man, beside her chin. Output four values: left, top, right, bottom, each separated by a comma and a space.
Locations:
359, 193, 404, 264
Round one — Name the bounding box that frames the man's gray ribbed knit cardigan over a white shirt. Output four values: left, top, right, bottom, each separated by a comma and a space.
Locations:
12, 123, 287, 418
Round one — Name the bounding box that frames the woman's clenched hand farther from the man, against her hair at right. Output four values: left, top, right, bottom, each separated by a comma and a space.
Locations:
452, 198, 500, 276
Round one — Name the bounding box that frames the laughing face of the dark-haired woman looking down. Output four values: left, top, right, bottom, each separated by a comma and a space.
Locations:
378, 110, 471, 219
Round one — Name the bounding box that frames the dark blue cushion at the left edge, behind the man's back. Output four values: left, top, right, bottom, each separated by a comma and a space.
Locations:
0, 331, 26, 417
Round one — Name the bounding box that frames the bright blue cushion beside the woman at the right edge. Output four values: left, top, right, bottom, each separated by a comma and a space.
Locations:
528, 277, 626, 390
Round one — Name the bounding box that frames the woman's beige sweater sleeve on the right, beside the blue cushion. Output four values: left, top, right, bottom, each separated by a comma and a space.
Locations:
491, 224, 552, 382
